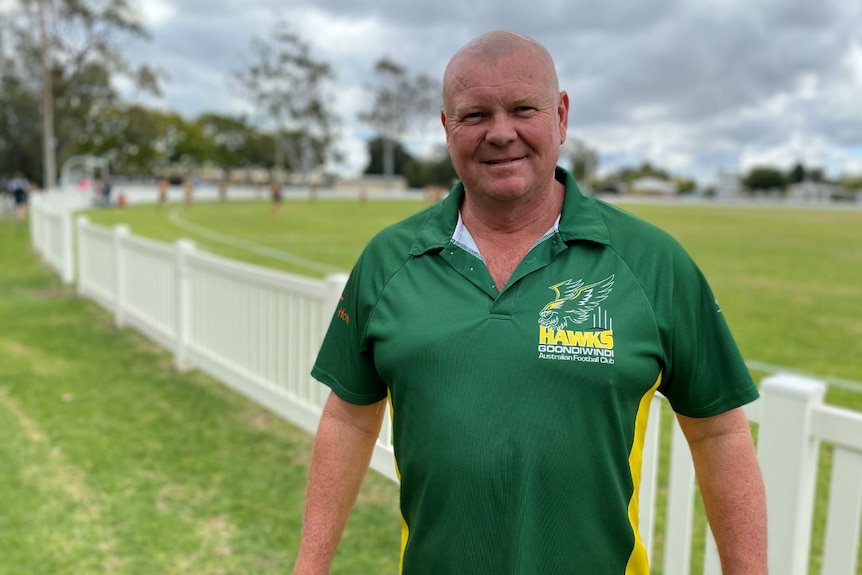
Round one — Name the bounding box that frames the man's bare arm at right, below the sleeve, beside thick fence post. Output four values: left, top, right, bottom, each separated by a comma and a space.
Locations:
677, 407, 767, 575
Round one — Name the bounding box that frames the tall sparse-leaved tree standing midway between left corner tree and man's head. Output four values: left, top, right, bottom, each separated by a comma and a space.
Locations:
235, 23, 336, 179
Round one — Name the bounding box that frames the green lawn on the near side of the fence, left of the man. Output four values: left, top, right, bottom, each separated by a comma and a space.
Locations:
0, 219, 400, 575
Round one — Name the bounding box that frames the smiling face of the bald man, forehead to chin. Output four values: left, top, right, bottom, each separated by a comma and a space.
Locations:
441, 51, 568, 206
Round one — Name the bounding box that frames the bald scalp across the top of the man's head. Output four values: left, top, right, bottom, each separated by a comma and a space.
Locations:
443, 30, 560, 102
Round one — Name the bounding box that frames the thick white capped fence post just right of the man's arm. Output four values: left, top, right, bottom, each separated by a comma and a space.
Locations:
757, 374, 826, 575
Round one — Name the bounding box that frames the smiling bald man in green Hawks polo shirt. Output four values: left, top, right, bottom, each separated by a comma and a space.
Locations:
295, 32, 766, 575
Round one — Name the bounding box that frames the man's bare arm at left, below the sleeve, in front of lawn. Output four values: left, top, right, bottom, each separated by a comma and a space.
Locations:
294, 393, 385, 575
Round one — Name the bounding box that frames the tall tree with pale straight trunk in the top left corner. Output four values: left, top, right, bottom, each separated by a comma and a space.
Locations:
0, 0, 159, 185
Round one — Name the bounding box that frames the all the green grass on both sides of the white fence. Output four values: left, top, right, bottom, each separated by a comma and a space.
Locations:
8, 196, 862, 575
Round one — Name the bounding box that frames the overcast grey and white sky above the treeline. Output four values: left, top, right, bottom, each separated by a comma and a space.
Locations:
116, 0, 862, 182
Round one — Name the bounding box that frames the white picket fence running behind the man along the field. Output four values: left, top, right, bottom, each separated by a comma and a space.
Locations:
31, 190, 862, 575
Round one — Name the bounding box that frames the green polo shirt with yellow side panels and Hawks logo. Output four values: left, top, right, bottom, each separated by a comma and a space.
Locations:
312, 168, 757, 575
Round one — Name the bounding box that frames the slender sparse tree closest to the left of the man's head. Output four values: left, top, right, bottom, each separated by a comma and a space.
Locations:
359, 58, 440, 184
